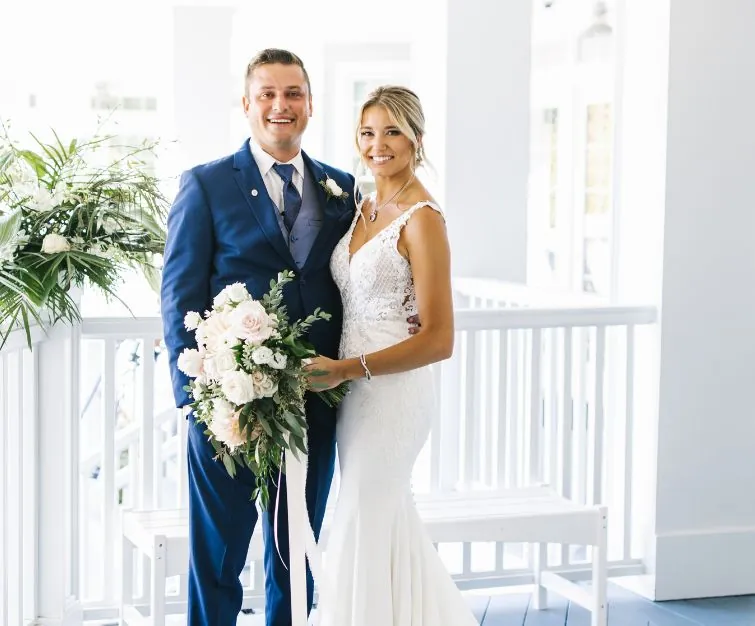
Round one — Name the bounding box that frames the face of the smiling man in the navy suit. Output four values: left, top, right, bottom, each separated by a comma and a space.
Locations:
242, 63, 312, 161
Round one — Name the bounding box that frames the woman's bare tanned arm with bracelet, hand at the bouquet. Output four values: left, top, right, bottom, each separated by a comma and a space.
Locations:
310, 207, 454, 389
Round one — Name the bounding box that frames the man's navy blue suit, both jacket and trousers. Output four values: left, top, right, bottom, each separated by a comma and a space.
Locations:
161, 142, 355, 626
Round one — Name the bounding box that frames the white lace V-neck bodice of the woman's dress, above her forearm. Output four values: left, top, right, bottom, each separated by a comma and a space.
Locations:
330, 201, 442, 358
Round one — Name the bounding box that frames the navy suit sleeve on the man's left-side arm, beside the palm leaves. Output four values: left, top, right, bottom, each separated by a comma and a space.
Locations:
160, 171, 215, 407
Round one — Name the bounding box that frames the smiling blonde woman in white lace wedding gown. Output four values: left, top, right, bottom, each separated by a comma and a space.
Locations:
308, 86, 477, 626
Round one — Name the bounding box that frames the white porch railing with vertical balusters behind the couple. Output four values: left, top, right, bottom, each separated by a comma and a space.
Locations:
0, 299, 656, 624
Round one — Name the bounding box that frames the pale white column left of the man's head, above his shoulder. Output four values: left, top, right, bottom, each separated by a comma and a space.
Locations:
173, 6, 236, 169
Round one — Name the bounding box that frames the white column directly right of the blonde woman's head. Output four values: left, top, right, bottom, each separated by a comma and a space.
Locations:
438, 0, 532, 282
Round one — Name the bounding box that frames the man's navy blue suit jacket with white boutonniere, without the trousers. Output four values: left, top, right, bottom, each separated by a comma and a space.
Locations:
161, 142, 354, 407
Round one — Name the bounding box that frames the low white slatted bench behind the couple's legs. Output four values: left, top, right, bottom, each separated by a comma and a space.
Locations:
121, 486, 607, 626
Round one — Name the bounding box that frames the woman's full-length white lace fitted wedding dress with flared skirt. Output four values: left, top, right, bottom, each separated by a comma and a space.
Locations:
316, 202, 477, 626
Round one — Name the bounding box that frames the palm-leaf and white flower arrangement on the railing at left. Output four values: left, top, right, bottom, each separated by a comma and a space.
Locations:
0, 124, 168, 347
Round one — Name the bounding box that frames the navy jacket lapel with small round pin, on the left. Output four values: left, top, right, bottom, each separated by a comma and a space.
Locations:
233, 142, 296, 267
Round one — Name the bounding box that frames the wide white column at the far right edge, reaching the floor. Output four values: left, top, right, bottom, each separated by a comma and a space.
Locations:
648, 0, 755, 599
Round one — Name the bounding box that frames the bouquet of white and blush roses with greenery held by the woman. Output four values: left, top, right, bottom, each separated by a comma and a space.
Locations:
178, 271, 347, 509
